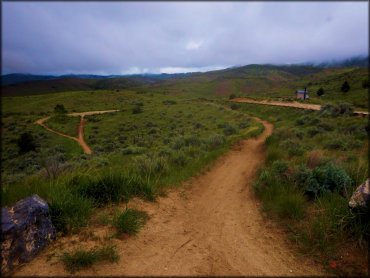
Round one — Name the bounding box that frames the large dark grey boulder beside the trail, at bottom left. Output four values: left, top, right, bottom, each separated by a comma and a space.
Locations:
1, 195, 56, 274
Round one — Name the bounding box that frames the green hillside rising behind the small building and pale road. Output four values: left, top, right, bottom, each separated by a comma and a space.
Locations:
143, 65, 368, 109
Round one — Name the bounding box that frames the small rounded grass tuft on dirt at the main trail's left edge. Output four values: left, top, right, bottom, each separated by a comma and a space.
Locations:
112, 208, 148, 235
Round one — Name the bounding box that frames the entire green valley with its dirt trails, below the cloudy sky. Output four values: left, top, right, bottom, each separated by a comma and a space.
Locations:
1, 65, 369, 276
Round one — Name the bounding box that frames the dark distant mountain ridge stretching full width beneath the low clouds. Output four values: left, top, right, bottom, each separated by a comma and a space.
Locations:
1, 54, 368, 96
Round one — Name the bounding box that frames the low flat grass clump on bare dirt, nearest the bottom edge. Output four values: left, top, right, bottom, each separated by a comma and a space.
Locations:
59, 245, 119, 273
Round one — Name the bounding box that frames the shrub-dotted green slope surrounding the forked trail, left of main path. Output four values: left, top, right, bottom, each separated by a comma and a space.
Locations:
2, 91, 261, 205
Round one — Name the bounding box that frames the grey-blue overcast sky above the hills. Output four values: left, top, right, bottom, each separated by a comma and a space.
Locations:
2, 2, 369, 74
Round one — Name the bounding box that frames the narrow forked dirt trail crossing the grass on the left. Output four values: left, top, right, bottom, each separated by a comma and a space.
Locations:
36, 110, 118, 154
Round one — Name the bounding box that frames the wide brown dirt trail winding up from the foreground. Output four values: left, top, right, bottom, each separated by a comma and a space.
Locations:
15, 113, 325, 276
